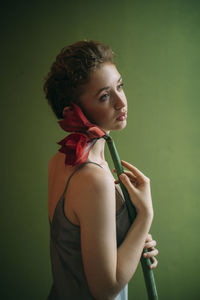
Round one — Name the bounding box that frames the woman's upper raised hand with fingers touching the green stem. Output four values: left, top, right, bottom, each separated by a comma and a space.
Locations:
113, 160, 153, 216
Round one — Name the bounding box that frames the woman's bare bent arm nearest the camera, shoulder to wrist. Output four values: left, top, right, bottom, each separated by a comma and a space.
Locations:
71, 165, 153, 300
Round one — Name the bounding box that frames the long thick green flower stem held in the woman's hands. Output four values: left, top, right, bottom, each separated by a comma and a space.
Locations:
103, 134, 158, 300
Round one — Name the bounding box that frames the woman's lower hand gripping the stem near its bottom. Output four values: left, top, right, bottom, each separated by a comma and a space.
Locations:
143, 234, 158, 269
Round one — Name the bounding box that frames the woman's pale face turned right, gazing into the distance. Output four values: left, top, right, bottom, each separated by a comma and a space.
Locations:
80, 63, 127, 133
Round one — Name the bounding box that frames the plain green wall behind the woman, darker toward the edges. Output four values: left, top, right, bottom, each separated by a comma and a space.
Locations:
0, 0, 200, 300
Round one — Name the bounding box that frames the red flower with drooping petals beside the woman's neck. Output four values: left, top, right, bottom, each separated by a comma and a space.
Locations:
58, 103, 106, 165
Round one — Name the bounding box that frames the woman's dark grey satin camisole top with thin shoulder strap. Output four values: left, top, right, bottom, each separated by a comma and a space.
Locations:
47, 162, 131, 300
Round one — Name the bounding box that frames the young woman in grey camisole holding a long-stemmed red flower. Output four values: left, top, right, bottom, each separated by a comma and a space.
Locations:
44, 41, 158, 300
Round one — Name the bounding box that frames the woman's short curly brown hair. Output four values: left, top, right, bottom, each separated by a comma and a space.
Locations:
43, 40, 114, 119
